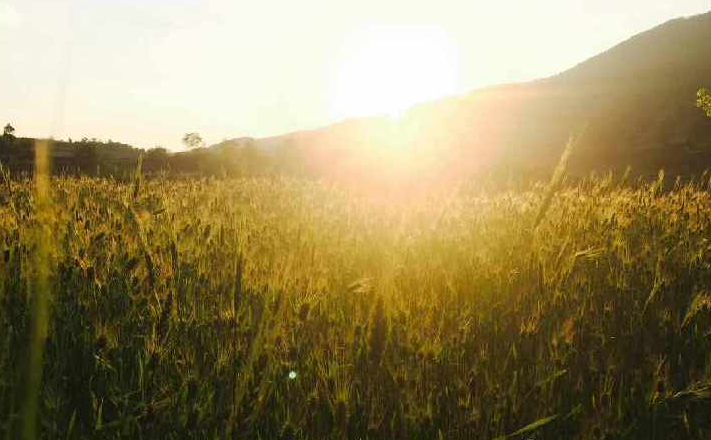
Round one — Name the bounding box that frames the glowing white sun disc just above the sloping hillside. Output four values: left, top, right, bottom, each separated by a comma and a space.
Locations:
332, 26, 459, 117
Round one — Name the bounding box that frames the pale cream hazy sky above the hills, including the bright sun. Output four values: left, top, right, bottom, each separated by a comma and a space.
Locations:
0, 0, 711, 149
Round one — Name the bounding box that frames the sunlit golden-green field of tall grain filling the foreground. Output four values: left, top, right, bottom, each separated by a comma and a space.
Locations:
0, 168, 711, 440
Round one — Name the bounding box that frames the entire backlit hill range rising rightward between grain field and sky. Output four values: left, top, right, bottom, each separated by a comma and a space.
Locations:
0, 12, 711, 181
